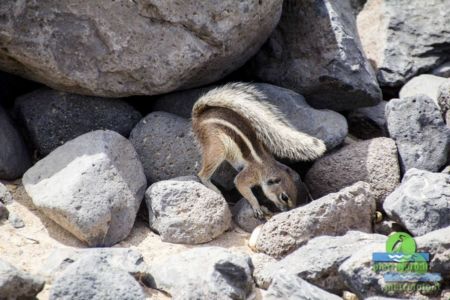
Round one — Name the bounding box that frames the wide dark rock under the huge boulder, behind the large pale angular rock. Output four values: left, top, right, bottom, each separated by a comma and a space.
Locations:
16, 89, 141, 156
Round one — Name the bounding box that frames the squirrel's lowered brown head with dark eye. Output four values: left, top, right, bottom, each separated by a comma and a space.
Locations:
261, 162, 300, 211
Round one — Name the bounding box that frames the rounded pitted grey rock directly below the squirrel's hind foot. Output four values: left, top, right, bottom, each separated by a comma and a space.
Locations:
145, 176, 231, 244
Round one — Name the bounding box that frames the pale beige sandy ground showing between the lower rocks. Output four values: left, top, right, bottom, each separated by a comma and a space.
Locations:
0, 181, 260, 299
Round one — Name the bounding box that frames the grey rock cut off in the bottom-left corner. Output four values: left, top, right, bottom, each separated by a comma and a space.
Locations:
0, 259, 45, 300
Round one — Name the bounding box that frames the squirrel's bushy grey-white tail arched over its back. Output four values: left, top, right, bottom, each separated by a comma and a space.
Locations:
192, 83, 326, 160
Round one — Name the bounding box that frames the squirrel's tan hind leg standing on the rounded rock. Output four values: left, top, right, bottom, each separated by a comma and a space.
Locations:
198, 138, 225, 194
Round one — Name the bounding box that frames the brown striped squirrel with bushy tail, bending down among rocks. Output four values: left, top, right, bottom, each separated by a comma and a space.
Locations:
192, 83, 326, 219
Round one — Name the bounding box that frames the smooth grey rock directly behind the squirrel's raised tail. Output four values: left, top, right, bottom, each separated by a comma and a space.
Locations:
154, 83, 348, 149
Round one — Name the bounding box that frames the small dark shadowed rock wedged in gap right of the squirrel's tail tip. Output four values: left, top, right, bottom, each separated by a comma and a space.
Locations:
347, 101, 388, 140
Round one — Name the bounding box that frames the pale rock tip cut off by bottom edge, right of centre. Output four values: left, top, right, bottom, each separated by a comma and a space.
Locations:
263, 273, 342, 300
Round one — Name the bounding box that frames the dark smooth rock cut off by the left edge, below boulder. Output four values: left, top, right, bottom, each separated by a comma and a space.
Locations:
0, 107, 31, 180
